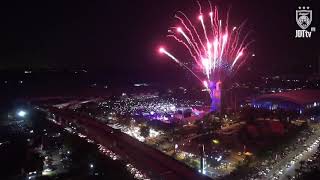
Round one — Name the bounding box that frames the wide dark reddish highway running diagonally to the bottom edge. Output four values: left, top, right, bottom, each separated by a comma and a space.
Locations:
45, 108, 210, 180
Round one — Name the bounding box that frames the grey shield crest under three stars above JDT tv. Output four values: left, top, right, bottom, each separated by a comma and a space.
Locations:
296, 6, 312, 29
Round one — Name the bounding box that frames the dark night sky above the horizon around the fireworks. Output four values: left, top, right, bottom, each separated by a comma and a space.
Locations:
0, 0, 320, 75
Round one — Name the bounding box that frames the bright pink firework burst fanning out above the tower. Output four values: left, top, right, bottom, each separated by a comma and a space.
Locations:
159, 2, 253, 87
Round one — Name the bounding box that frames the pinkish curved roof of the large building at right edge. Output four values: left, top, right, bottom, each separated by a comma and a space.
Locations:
255, 90, 320, 105
